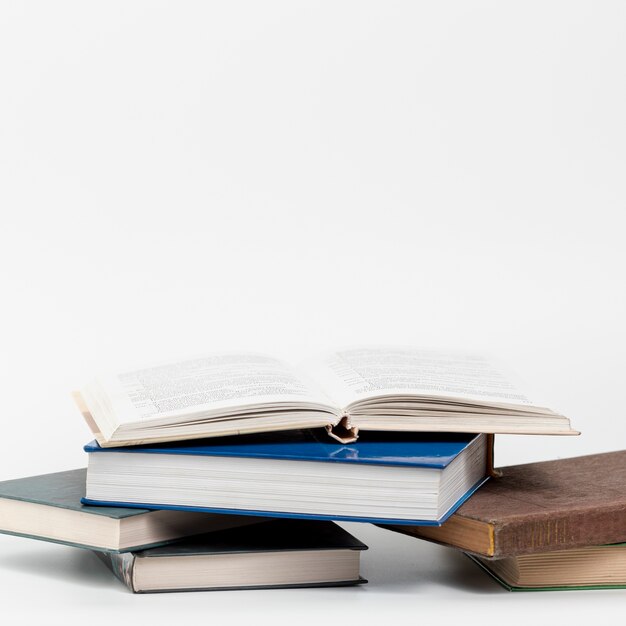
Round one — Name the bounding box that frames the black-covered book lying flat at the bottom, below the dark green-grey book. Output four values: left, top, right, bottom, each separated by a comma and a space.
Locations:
98, 520, 367, 593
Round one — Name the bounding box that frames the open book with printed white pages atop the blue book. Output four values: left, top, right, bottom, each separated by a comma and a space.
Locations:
75, 348, 577, 447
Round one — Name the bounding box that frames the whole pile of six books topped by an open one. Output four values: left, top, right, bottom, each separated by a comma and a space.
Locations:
0, 348, 626, 592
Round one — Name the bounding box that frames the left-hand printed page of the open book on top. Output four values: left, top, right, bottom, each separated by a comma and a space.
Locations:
82, 354, 333, 430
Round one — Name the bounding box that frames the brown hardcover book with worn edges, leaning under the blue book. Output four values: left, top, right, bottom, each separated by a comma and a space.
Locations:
384, 450, 626, 558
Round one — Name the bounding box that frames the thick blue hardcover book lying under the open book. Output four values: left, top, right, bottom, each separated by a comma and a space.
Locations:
83, 430, 492, 525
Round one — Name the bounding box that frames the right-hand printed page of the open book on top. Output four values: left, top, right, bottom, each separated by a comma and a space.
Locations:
303, 348, 533, 410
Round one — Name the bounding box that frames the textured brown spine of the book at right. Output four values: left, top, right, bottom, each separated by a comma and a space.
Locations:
494, 504, 626, 557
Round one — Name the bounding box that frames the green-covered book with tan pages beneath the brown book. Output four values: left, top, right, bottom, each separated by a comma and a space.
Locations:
467, 543, 626, 591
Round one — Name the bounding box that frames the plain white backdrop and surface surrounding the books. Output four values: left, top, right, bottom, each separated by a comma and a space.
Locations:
0, 0, 626, 624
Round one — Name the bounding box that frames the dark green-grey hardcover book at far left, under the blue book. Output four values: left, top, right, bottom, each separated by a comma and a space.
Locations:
0, 468, 259, 552
